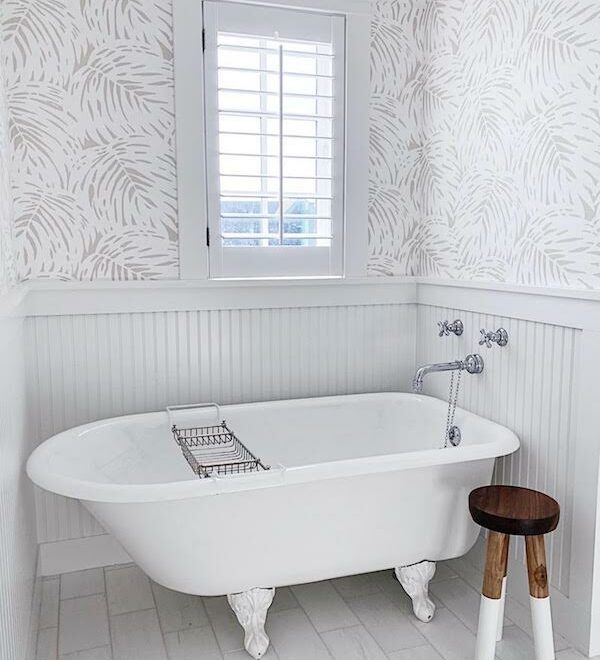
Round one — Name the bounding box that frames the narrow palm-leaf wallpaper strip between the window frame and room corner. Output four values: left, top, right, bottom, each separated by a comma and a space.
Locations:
368, 0, 425, 275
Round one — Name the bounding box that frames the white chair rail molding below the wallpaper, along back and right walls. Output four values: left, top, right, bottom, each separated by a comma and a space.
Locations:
21, 276, 600, 324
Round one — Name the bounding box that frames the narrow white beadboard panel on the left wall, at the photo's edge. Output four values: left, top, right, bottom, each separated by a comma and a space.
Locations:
0, 315, 37, 660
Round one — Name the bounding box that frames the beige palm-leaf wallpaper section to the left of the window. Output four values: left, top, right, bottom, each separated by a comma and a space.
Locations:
2, 0, 178, 280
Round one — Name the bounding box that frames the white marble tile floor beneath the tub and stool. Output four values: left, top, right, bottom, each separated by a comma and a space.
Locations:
36, 564, 583, 660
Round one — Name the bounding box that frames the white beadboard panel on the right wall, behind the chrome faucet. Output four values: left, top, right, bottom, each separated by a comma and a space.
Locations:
417, 305, 581, 596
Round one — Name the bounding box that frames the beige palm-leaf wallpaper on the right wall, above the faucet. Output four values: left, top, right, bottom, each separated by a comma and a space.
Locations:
404, 0, 600, 288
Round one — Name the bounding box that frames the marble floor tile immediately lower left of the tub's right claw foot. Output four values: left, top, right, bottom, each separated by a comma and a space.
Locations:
348, 593, 426, 653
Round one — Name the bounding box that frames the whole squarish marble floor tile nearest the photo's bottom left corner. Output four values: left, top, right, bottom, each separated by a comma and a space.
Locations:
58, 595, 110, 654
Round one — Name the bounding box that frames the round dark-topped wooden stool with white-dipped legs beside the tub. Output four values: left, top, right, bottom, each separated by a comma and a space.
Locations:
469, 486, 560, 660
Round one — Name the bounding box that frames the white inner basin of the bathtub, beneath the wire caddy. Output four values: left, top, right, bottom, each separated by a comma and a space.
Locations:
36, 393, 508, 485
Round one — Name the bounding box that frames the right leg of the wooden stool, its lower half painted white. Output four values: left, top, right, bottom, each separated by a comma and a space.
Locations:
525, 536, 554, 660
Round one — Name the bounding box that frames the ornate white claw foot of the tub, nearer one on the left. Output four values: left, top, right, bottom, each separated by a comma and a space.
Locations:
227, 589, 275, 659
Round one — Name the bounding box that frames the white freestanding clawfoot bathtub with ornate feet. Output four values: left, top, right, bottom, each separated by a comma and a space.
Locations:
27, 393, 519, 658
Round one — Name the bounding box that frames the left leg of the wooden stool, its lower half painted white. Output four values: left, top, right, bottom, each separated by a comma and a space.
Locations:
475, 532, 509, 660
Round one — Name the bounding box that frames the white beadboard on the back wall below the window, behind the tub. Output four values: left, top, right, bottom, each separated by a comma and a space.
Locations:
26, 304, 416, 543
